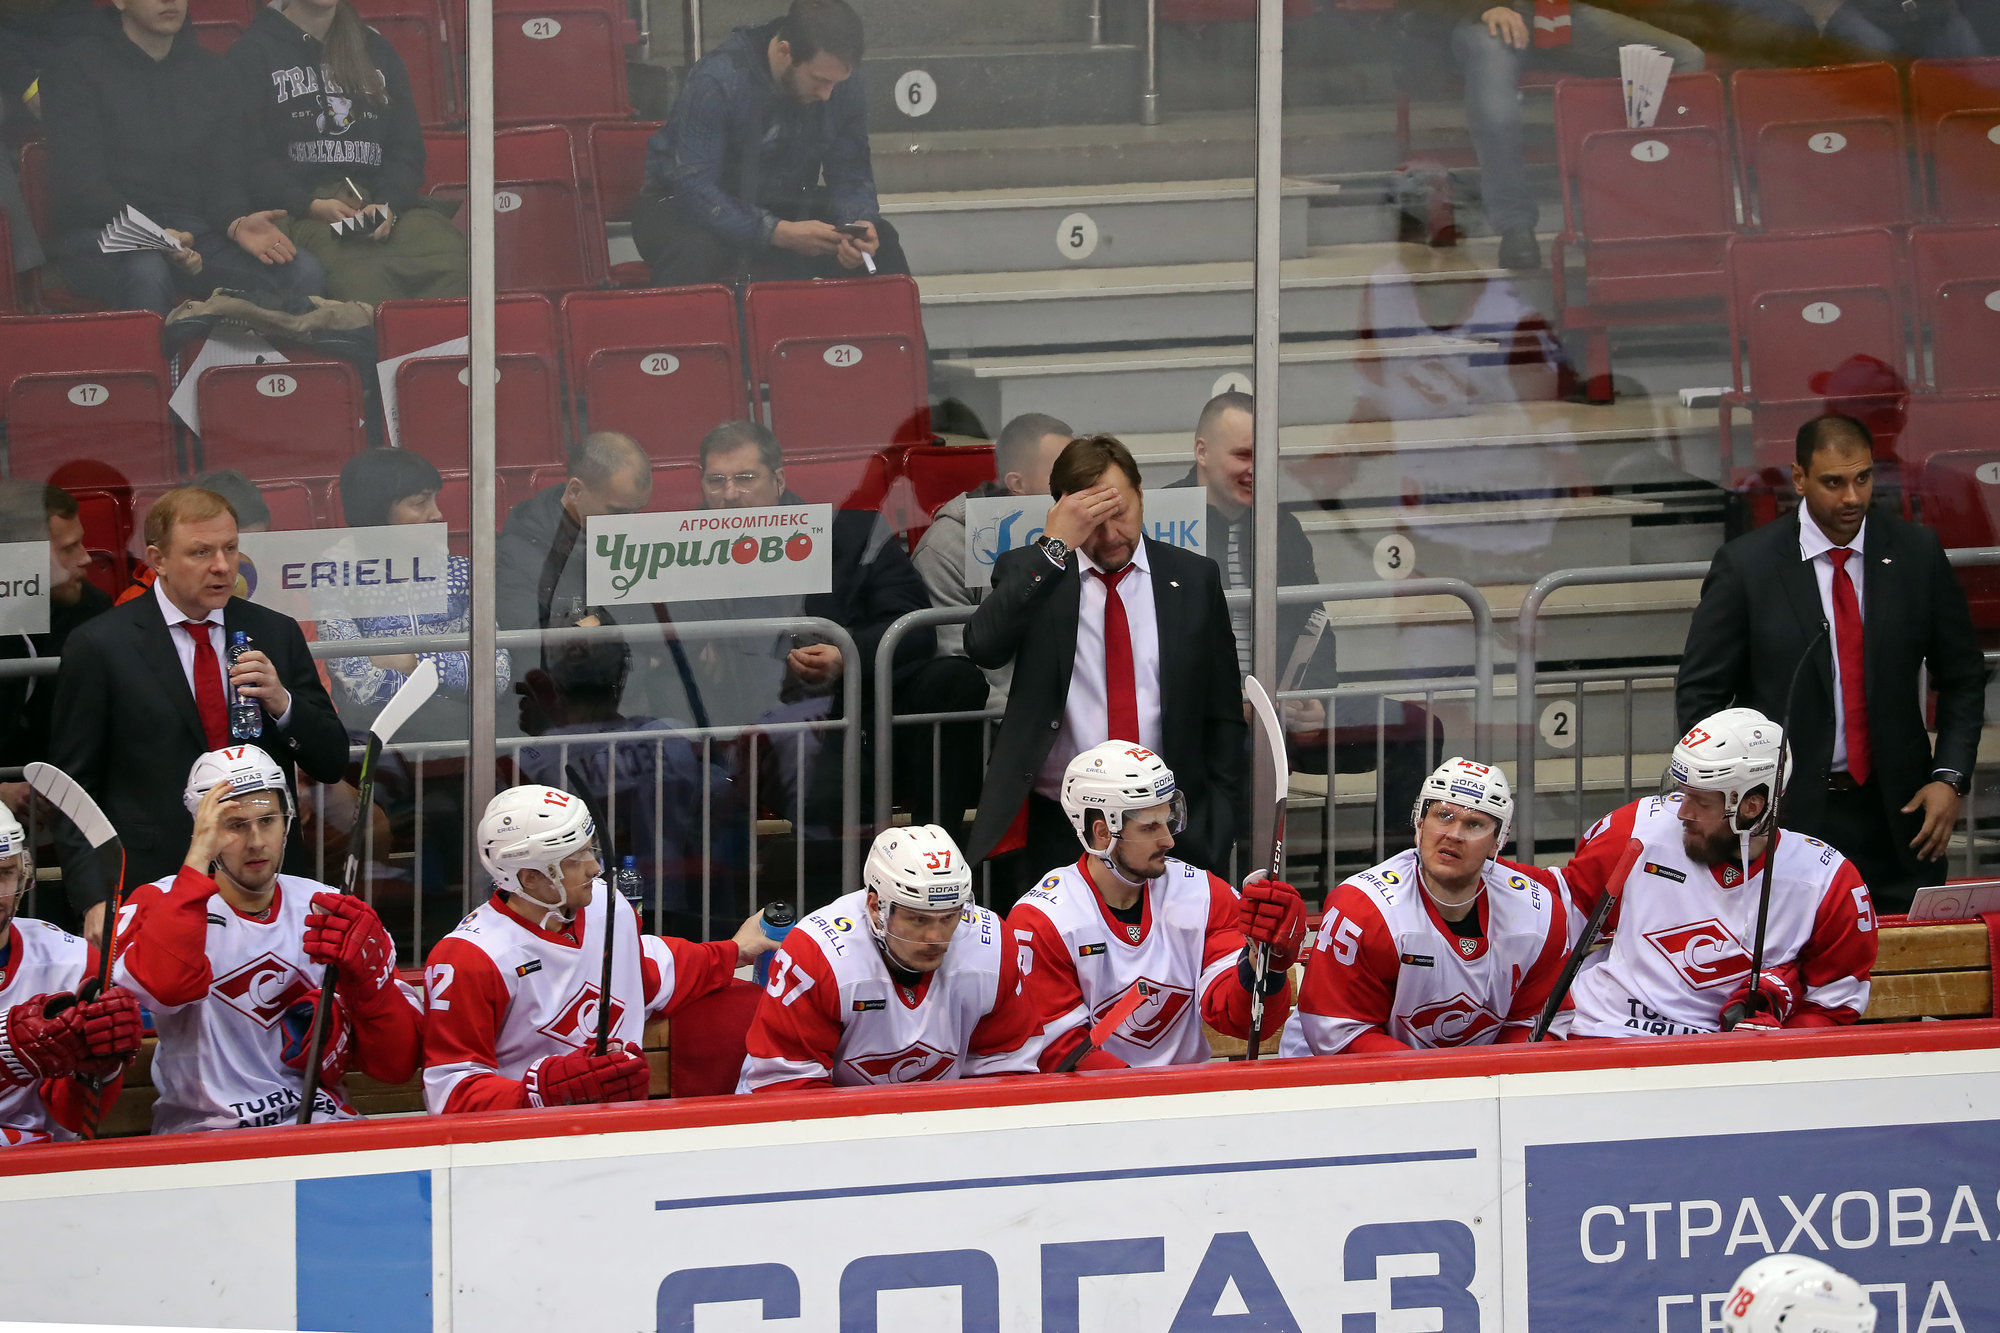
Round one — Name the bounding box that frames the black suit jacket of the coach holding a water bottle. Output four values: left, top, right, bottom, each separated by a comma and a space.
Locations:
50, 592, 348, 913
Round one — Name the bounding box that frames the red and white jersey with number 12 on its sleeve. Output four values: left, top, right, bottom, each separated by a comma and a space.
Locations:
424, 879, 738, 1115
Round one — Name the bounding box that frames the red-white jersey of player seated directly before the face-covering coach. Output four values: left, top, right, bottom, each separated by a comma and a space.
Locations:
1006, 857, 1290, 1067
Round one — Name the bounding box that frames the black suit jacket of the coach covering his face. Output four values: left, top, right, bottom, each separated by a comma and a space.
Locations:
966, 538, 1248, 871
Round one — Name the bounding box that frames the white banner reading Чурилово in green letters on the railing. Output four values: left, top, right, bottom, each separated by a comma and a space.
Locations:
584, 504, 834, 606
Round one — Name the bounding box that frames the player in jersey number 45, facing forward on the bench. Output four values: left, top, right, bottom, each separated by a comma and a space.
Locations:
1278, 759, 1570, 1055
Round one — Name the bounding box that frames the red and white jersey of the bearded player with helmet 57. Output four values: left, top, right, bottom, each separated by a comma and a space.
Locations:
1562, 793, 1876, 1037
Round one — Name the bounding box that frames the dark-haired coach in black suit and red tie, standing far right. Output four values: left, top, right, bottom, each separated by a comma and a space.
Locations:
1674, 414, 1986, 913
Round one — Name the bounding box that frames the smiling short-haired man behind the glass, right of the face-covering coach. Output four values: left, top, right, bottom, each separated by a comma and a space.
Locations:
1172, 390, 1444, 837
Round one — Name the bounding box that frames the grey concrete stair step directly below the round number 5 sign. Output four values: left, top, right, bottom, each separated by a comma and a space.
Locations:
918, 239, 1552, 352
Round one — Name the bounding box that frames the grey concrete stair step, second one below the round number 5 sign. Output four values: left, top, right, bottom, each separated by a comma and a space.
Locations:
932, 334, 1556, 432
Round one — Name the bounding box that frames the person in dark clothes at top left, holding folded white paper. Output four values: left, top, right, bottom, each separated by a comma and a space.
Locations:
40, 0, 324, 314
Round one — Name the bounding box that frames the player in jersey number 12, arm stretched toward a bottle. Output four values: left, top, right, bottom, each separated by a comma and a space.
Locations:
424, 787, 772, 1115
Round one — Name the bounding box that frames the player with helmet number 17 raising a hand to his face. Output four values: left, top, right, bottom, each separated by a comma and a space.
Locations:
116, 745, 422, 1135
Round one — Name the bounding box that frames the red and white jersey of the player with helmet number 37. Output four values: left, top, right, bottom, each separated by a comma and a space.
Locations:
736, 889, 1044, 1093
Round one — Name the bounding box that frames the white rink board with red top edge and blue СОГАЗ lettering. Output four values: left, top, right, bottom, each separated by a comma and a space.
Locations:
0, 1023, 2000, 1333
